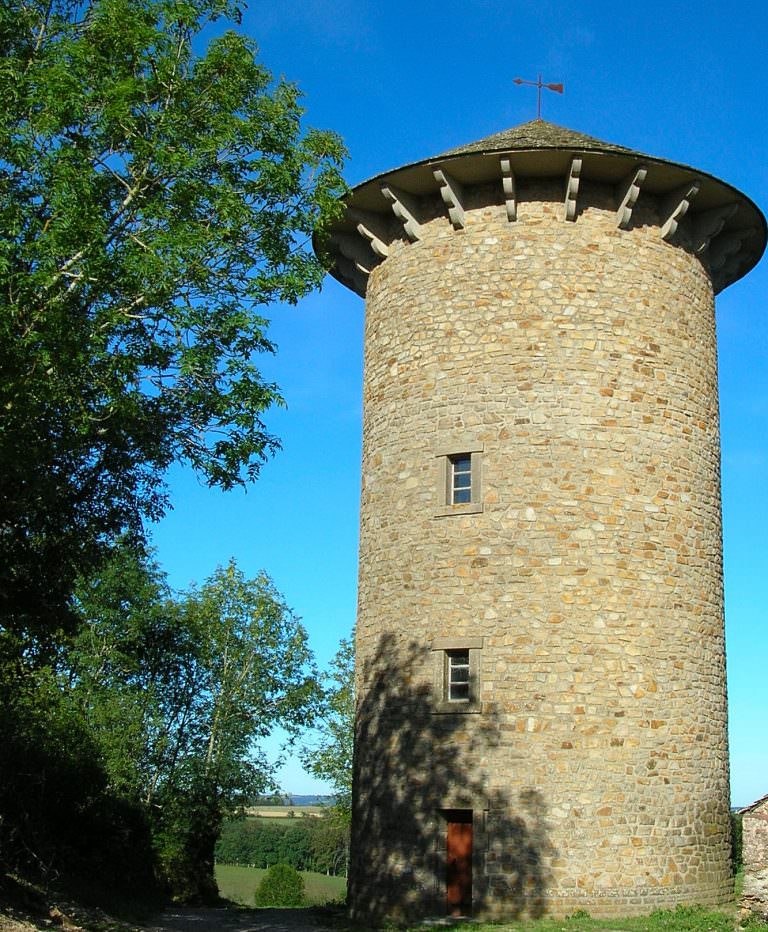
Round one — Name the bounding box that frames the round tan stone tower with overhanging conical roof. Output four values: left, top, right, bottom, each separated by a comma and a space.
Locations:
316, 120, 765, 920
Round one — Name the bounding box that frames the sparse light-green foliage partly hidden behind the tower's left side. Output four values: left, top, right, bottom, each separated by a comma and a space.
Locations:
302, 640, 355, 821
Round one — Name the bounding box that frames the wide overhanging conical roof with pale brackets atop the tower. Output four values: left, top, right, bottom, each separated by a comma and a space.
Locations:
316, 119, 766, 295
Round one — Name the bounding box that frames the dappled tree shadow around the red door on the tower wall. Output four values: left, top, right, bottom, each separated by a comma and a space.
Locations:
349, 634, 557, 923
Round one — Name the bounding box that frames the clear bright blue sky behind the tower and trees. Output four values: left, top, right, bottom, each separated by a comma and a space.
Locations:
154, 0, 768, 805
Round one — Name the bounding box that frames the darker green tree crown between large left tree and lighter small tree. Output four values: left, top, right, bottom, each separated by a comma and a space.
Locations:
68, 538, 191, 807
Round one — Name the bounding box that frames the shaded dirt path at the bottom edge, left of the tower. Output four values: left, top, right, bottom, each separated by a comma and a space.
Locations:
143, 906, 332, 932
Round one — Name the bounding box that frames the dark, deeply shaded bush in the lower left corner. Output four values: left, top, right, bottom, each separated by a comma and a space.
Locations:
0, 648, 157, 904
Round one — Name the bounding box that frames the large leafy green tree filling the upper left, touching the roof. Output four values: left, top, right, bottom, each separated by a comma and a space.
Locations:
0, 0, 344, 648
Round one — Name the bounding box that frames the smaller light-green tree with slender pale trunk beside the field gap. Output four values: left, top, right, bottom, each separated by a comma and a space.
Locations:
147, 564, 316, 898
